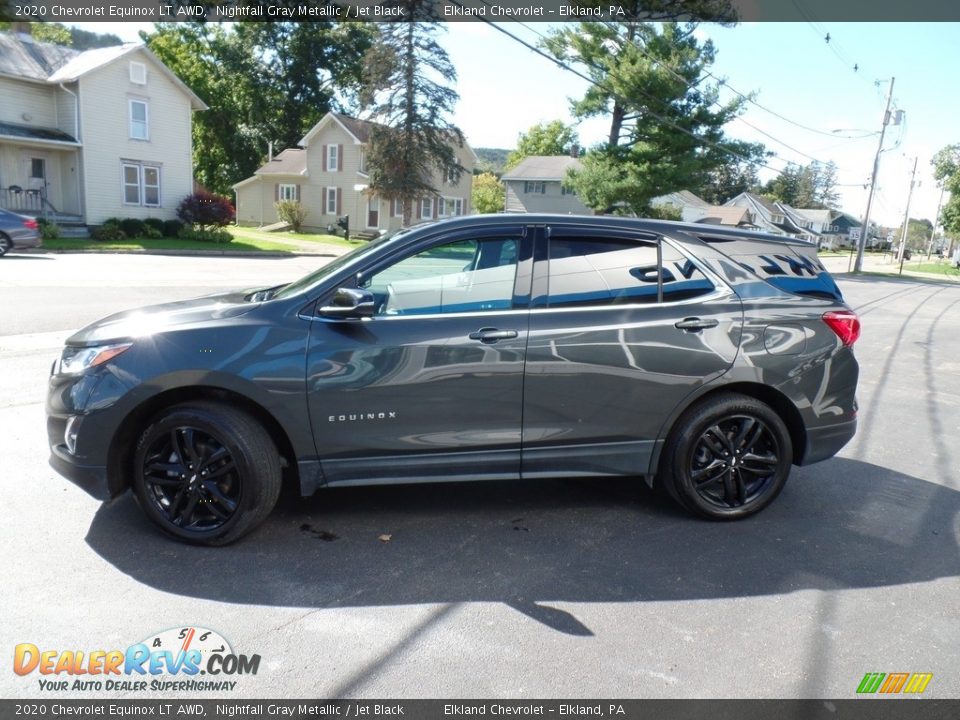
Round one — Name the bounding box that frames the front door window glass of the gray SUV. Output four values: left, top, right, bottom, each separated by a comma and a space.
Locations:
363, 237, 520, 316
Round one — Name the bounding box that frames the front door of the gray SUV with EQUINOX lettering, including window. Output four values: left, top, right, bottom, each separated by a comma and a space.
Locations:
307, 224, 532, 483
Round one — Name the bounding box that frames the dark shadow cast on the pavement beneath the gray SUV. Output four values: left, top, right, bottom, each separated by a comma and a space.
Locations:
86, 459, 960, 635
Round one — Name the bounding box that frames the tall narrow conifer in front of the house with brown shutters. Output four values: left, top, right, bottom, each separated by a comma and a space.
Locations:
361, 0, 463, 225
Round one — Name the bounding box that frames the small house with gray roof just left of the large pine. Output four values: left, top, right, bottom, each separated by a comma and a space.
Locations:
503, 155, 594, 215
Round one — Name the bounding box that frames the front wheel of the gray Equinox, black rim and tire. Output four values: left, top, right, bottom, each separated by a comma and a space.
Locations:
133, 402, 281, 545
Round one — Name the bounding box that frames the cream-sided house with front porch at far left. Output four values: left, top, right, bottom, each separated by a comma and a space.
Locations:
0, 33, 206, 225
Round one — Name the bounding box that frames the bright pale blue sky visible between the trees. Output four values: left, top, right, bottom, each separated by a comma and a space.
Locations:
63, 22, 960, 227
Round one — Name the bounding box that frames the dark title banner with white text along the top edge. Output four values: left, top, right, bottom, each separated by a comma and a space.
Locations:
0, 0, 960, 22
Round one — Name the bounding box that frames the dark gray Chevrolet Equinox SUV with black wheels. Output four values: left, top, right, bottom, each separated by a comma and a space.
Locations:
47, 215, 860, 545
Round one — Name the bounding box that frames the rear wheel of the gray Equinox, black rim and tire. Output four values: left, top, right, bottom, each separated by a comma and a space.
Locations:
658, 393, 793, 520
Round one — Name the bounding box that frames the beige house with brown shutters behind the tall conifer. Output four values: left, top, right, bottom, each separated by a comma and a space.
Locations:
233, 112, 477, 233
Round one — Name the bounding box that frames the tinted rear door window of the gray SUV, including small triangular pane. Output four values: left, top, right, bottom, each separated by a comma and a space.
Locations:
548, 237, 713, 307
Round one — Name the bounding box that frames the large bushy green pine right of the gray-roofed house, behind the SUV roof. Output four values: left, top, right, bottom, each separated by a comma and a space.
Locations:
546, 21, 763, 214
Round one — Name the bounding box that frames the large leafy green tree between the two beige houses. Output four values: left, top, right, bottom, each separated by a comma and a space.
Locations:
144, 22, 373, 193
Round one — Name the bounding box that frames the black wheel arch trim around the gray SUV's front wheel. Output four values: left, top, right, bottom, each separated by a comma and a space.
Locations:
107, 385, 299, 497
